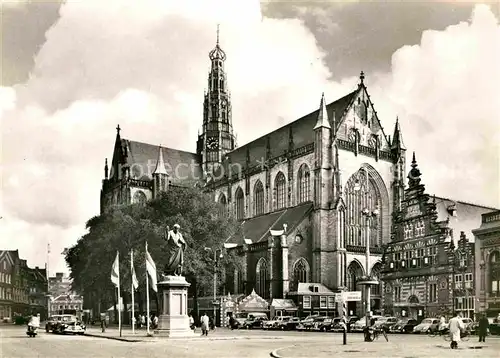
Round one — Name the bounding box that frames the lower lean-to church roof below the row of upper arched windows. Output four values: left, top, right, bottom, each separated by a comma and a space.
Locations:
228, 202, 312, 245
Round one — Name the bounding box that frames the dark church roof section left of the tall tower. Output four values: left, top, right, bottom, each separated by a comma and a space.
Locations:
122, 139, 203, 184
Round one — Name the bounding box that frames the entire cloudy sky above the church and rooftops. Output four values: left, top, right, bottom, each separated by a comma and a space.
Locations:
0, 0, 500, 272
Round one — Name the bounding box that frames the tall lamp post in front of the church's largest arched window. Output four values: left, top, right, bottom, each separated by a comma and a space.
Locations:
354, 168, 379, 341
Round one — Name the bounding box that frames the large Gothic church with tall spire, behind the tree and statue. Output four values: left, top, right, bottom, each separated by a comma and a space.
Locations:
101, 31, 494, 315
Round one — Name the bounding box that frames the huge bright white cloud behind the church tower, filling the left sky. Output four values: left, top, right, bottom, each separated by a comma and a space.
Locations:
2, 0, 332, 270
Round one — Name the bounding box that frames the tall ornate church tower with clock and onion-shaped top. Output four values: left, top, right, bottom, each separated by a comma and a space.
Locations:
196, 26, 235, 173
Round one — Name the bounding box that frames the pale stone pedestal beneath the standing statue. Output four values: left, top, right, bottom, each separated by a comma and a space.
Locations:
154, 276, 194, 337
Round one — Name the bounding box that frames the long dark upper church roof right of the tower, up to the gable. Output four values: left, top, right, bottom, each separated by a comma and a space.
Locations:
214, 88, 359, 177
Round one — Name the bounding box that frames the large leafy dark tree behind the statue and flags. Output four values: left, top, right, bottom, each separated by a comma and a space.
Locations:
66, 188, 239, 310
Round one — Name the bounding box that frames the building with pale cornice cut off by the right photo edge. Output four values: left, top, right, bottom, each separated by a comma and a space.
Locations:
474, 210, 500, 317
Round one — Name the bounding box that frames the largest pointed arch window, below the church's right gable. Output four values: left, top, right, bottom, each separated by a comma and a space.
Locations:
345, 170, 382, 247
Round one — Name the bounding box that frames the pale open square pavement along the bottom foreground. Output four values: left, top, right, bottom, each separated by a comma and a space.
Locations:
0, 326, 500, 358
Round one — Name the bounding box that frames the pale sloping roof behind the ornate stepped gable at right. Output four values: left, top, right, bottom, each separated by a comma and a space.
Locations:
431, 196, 497, 244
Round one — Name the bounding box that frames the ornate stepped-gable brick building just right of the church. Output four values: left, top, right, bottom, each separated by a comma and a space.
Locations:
381, 158, 491, 318
